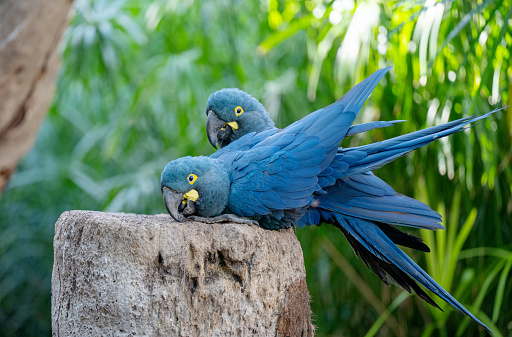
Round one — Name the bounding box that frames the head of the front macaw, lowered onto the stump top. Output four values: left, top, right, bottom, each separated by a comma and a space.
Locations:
160, 157, 230, 222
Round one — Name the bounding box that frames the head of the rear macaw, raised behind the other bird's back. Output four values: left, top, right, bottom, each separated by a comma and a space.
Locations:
206, 88, 274, 148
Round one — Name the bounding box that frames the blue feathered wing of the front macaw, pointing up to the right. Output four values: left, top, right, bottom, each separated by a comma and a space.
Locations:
212, 67, 390, 216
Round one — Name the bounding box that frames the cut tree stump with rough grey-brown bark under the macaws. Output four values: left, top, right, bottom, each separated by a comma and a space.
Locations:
52, 211, 314, 336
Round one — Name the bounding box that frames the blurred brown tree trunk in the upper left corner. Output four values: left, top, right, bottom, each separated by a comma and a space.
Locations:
0, 0, 72, 194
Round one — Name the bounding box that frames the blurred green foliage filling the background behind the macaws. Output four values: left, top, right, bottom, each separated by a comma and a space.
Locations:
0, 0, 512, 336
